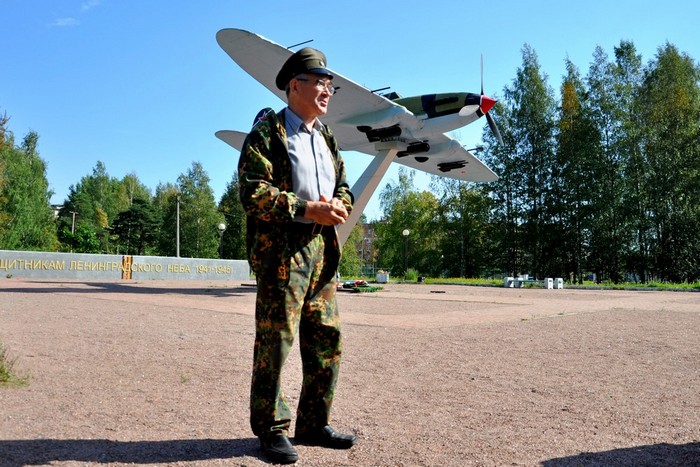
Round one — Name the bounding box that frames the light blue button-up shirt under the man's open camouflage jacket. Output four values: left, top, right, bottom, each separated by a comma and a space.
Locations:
285, 108, 335, 222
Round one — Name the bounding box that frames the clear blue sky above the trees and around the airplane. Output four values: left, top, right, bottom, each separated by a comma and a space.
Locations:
0, 0, 700, 219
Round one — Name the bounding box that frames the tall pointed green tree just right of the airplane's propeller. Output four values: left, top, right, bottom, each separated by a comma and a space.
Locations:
487, 45, 556, 276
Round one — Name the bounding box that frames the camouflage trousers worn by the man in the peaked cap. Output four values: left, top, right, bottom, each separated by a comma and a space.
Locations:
250, 235, 342, 436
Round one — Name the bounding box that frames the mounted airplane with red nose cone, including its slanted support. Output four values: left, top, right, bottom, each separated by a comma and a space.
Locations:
216, 29, 501, 244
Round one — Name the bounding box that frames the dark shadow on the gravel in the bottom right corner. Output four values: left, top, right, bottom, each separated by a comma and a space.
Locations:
542, 442, 700, 467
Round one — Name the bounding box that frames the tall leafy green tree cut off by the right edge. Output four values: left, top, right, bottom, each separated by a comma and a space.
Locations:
638, 44, 700, 281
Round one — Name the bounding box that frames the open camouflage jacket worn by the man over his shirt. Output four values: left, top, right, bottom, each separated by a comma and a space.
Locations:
238, 109, 353, 282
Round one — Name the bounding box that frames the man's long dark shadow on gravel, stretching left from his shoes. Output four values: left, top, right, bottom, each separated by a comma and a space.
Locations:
0, 438, 261, 467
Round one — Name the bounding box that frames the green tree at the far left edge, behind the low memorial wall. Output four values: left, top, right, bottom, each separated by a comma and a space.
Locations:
0, 131, 58, 251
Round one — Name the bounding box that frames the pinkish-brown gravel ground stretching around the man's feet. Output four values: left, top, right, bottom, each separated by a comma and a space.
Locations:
0, 278, 700, 467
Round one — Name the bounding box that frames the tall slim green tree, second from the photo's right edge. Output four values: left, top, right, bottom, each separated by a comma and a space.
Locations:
586, 41, 643, 282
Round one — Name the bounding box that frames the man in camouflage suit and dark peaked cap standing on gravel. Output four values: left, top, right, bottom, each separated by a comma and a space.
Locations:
238, 48, 355, 463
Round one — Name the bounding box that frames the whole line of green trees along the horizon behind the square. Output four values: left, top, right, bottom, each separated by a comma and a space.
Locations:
0, 41, 700, 283
